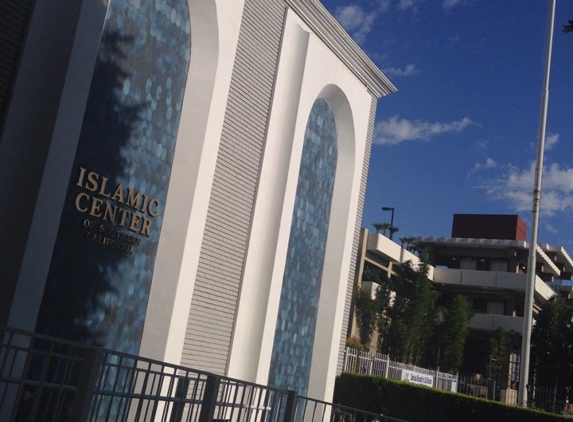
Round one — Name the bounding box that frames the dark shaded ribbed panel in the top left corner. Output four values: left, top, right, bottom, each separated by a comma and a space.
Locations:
0, 0, 33, 128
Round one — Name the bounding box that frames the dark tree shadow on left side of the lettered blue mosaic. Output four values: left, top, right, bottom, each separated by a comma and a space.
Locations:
36, 31, 143, 346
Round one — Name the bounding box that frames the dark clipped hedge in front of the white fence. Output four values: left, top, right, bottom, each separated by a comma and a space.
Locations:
334, 373, 572, 422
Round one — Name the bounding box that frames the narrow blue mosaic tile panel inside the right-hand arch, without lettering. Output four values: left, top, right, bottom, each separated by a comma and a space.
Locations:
269, 99, 338, 395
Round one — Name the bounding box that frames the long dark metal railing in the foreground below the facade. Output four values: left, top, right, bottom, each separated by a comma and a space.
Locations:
0, 327, 412, 422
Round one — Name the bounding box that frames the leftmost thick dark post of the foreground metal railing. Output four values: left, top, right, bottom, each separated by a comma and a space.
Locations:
70, 349, 100, 422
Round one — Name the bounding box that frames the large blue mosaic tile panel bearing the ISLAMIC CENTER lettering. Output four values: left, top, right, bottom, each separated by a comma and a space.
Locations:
36, 0, 191, 353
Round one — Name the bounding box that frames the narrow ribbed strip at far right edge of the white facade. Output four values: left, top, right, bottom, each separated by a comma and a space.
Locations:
336, 97, 377, 374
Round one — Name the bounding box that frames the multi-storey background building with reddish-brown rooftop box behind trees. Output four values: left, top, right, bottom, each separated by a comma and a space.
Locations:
348, 218, 573, 402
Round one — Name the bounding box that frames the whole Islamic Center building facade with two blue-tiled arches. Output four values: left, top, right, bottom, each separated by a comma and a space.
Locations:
0, 0, 395, 399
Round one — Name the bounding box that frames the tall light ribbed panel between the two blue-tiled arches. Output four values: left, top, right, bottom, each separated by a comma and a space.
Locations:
182, 0, 285, 374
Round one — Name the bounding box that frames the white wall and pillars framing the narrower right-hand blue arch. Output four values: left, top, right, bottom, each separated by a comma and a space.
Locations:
229, 8, 378, 400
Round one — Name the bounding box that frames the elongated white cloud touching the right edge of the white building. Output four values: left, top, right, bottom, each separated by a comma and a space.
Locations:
374, 116, 475, 145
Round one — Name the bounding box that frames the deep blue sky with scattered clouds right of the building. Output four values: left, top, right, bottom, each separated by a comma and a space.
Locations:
322, 0, 573, 251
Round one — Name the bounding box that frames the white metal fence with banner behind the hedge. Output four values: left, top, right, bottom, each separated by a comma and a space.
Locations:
342, 348, 458, 392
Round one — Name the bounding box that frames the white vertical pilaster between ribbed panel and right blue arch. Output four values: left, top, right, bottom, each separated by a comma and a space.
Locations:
229, 20, 309, 383
